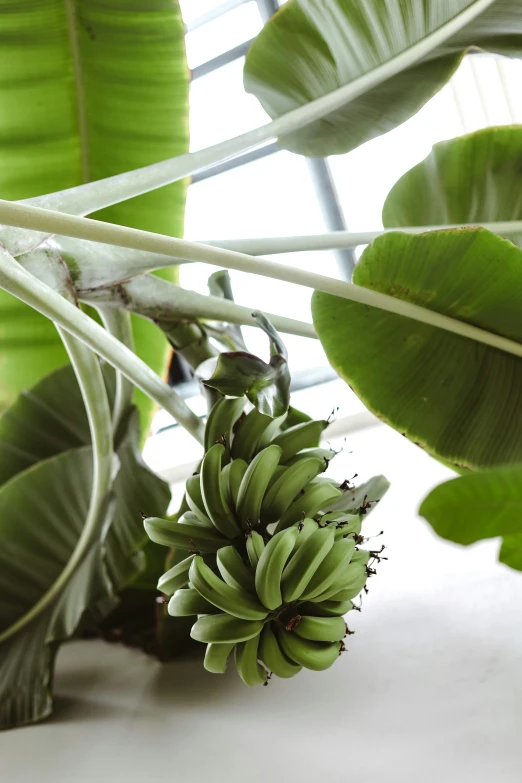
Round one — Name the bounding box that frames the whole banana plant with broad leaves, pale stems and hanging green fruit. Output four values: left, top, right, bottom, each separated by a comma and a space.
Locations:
0, 0, 522, 726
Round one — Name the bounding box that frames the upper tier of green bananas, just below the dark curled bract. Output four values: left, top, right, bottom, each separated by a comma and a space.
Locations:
145, 398, 342, 553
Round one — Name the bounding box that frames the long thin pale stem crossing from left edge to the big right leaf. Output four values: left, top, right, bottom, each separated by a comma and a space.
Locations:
0, 200, 522, 362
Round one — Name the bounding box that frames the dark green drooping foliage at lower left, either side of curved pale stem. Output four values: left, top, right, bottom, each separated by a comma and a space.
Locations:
0, 367, 170, 728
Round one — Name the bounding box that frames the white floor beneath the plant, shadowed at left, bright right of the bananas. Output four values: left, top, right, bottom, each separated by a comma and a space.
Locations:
4, 427, 522, 783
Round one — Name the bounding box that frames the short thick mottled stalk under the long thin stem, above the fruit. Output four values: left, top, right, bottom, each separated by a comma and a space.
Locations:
78, 275, 316, 338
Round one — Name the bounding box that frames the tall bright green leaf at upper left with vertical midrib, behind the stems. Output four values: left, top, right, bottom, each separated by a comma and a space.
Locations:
0, 0, 189, 426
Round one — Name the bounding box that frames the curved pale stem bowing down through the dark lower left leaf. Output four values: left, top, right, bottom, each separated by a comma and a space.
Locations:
0, 330, 114, 643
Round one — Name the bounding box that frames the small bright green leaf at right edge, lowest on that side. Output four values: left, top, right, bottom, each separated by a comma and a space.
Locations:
420, 465, 522, 571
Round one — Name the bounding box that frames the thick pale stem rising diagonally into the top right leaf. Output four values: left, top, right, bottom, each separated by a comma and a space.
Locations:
20, 0, 494, 222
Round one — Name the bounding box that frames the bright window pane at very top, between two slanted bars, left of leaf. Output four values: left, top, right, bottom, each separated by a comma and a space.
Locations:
185, 2, 263, 68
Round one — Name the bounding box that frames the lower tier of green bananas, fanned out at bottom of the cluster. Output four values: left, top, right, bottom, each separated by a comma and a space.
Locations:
165, 518, 370, 685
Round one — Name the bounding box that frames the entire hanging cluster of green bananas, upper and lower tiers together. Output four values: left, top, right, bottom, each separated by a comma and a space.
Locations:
144, 398, 378, 685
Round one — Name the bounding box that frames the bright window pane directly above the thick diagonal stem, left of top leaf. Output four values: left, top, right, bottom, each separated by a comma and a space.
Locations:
190, 57, 270, 150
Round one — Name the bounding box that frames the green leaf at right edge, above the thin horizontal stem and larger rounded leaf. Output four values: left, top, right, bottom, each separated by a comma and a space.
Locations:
383, 125, 522, 245
